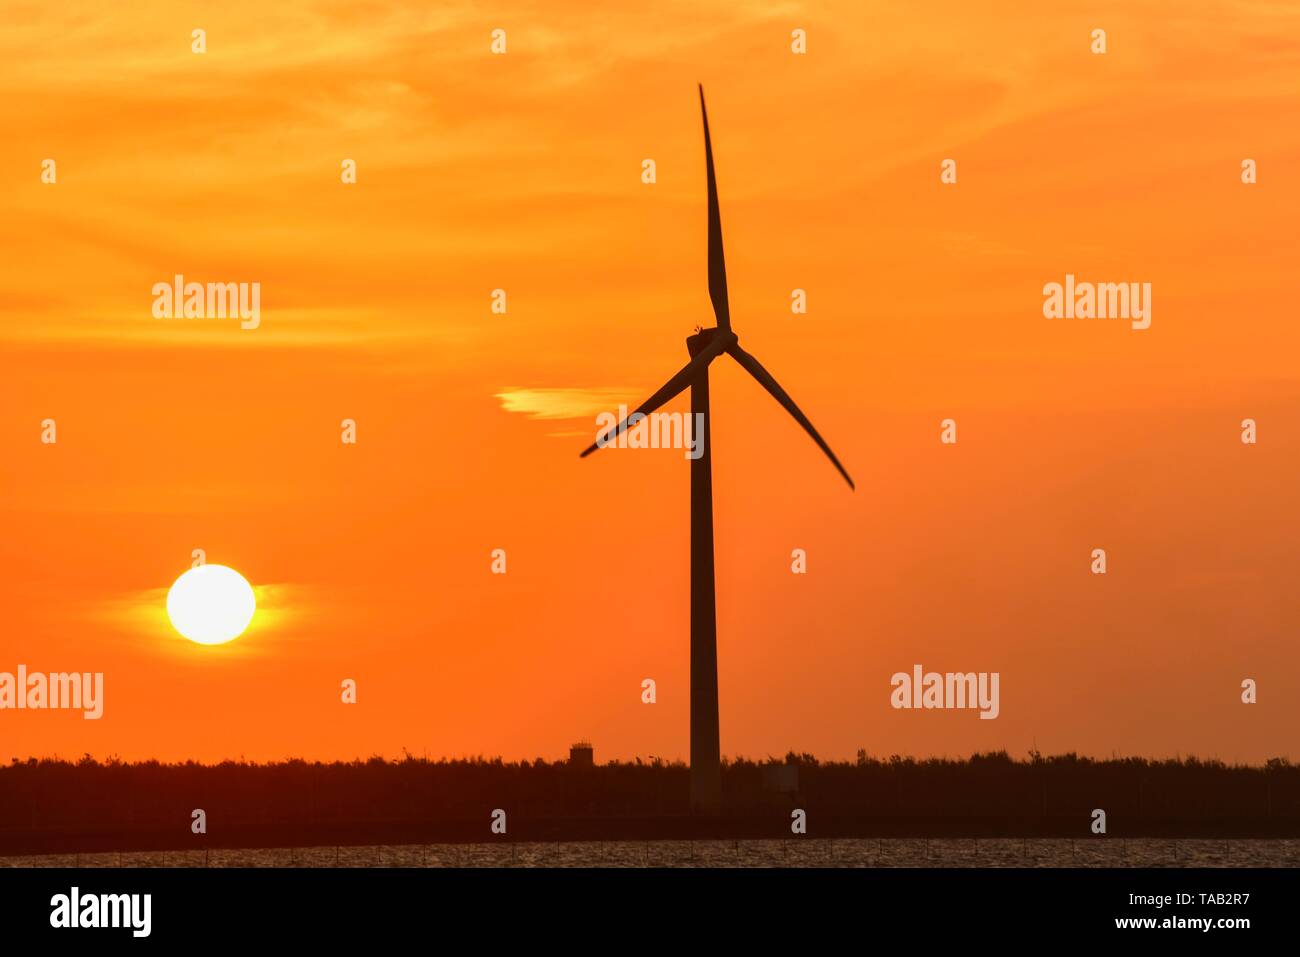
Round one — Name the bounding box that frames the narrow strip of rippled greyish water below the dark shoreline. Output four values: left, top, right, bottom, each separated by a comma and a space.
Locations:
0, 836, 1300, 867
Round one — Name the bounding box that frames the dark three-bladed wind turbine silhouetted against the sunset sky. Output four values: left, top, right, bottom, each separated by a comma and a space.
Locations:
582, 85, 854, 810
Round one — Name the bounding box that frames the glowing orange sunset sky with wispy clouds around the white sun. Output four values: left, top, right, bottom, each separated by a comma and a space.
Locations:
0, 0, 1300, 761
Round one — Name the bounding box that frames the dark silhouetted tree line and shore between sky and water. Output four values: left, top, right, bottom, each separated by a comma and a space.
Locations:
0, 752, 1300, 853
